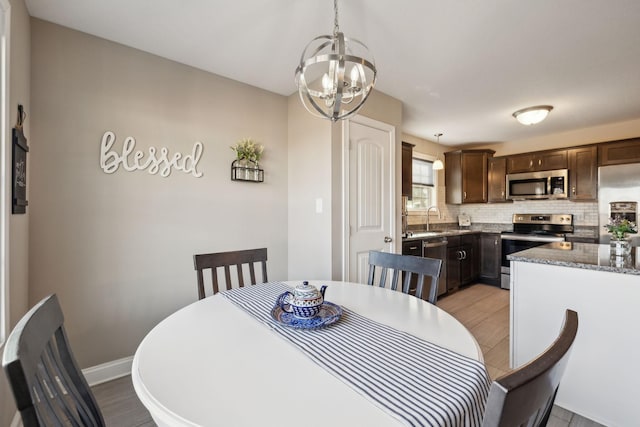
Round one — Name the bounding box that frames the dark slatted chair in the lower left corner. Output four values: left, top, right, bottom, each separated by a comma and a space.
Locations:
2, 294, 105, 427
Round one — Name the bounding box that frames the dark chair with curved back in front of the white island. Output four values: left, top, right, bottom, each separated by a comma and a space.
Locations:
482, 310, 578, 427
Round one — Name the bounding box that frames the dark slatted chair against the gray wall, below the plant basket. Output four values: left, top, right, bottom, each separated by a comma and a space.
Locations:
193, 248, 269, 299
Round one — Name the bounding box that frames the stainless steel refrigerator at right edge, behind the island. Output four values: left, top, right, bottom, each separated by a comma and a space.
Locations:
598, 163, 640, 246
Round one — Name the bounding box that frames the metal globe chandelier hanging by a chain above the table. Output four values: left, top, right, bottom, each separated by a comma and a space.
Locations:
296, 0, 377, 122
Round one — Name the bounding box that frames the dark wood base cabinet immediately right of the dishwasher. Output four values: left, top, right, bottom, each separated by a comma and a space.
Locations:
447, 234, 479, 292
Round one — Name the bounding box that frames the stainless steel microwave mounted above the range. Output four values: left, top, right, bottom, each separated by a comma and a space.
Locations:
507, 169, 569, 200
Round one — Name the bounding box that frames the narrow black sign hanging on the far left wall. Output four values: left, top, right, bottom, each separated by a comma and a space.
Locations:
11, 105, 29, 214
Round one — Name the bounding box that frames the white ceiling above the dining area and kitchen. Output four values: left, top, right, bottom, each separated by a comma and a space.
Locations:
26, 0, 640, 145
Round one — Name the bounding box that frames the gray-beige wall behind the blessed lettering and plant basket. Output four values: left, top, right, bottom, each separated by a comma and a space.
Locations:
29, 19, 287, 368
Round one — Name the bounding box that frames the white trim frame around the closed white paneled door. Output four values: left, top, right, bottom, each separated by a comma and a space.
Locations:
341, 114, 397, 281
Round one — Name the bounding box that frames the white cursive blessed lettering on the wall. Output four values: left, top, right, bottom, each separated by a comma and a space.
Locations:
100, 131, 203, 178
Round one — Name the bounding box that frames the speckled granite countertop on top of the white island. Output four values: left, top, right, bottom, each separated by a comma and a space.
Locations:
507, 242, 640, 275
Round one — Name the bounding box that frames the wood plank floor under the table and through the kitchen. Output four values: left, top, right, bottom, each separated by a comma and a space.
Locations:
93, 284, 602, 427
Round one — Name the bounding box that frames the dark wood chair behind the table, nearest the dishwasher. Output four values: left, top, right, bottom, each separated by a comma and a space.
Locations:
367, 251, 442, 304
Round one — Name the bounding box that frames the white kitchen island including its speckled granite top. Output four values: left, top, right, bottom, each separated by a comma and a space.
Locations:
508, 242, 640, 426
